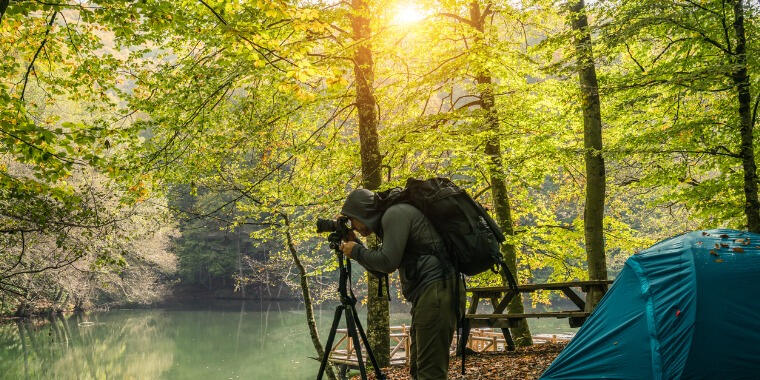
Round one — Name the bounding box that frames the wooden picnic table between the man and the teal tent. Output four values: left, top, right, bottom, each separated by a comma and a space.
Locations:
459, 280, 612, 351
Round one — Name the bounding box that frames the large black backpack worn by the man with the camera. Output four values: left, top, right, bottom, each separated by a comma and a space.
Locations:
377, 178, 517, 289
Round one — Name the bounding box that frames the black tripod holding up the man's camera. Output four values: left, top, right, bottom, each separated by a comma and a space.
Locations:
317, 233, 385, 380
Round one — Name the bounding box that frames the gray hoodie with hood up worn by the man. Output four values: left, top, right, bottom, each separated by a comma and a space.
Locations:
341, 189, 453, 302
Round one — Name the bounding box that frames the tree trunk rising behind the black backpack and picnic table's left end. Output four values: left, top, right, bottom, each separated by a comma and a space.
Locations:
470, 1, 533, 347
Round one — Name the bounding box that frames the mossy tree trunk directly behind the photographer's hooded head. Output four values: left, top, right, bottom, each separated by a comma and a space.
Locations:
351, 0, 390, 367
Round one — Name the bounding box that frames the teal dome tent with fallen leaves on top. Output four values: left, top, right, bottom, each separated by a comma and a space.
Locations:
541, 229, 760, 380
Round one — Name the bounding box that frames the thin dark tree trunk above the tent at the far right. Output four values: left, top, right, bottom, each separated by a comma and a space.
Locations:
731, 0, 760, 233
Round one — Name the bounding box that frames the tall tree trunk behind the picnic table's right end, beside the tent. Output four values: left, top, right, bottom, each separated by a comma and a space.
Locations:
570, 0, 607, 311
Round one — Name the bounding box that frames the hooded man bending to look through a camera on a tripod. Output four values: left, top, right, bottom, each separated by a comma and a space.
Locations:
340, 189, 464, 380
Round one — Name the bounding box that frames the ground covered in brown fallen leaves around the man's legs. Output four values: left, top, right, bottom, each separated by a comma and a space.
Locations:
351, 343, 566, 380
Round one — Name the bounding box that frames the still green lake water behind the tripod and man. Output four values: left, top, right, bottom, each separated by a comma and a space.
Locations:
0, 303, 575, 380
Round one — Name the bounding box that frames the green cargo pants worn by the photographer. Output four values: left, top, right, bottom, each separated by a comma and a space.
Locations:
409, 278, 465, 380
